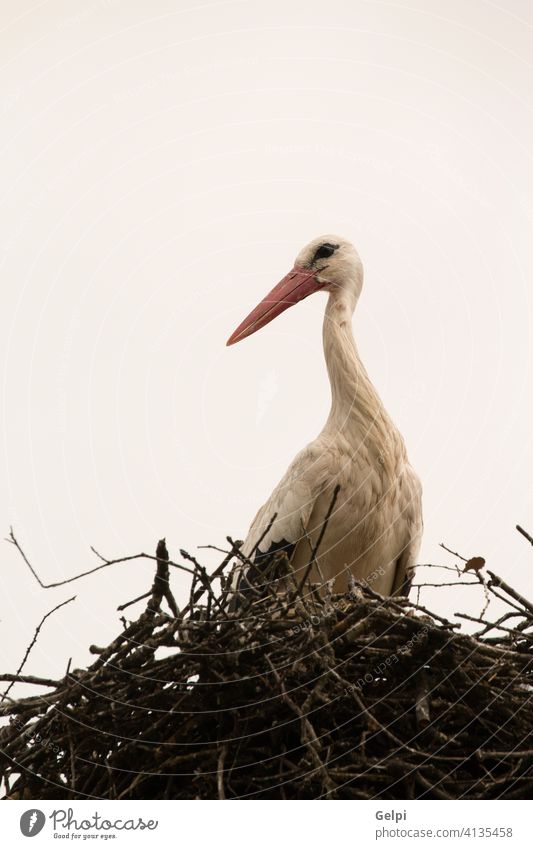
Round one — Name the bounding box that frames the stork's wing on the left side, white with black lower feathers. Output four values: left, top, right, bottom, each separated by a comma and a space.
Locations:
233, 440, 327, 586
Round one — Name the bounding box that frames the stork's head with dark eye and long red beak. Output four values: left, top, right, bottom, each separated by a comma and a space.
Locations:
226, 236, 363, 345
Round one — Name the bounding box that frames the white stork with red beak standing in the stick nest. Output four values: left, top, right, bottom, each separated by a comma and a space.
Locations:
227, 236, 422, 595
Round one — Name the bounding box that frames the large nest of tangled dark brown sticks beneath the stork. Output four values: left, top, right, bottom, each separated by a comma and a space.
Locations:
0, 541, 533, 799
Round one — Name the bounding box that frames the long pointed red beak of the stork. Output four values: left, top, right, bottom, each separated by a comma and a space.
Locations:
226, 266, 324, 345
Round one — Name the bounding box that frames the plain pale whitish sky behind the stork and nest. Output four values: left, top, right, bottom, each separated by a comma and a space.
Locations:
0, 0, 533, 675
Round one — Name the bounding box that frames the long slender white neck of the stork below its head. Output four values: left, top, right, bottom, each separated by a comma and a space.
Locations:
323, 290, 403, 471
